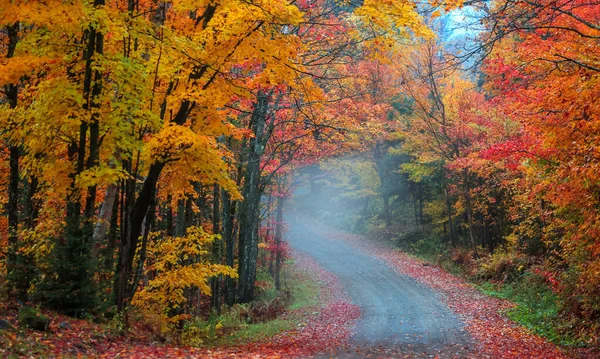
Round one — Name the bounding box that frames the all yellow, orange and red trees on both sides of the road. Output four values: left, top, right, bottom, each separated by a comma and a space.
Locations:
0, 0, 600, 354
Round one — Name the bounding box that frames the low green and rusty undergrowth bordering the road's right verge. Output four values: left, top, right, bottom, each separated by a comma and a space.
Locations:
386, 232, 586, 347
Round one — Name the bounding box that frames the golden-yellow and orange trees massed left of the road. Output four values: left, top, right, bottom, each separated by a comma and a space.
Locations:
0, 0, 432, 346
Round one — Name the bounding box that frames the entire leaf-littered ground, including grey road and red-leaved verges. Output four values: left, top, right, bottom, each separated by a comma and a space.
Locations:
0, 212, 599, 359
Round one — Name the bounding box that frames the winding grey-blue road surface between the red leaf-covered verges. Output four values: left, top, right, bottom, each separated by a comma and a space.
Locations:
286, 214, 472, 358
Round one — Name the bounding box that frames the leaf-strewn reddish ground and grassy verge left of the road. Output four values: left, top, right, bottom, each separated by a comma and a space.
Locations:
0, 253, 360, 359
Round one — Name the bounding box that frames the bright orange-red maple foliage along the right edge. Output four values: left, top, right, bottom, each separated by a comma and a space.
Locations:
486, 1, 600, 330
